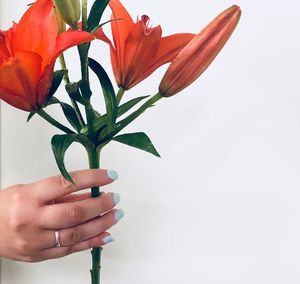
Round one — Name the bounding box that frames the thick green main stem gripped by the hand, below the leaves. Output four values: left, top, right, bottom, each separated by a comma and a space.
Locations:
87, 148, 102, 284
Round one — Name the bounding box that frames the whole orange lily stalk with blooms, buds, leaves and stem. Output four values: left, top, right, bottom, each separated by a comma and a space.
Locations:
0, 0, 241, 284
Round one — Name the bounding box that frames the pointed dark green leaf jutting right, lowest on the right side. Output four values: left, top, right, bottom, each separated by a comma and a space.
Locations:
112, 132, 160, 157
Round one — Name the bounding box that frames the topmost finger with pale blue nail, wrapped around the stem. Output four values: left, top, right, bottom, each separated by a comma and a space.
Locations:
35, 169, 118, 202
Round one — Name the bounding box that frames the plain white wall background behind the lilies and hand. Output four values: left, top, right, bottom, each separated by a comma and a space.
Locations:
0, 0, 300, 284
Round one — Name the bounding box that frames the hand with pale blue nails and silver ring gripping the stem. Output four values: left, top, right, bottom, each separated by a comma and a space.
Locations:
0, 170, 123, 262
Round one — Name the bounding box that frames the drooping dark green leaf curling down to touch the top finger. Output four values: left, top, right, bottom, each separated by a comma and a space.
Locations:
51, 135, 76, 184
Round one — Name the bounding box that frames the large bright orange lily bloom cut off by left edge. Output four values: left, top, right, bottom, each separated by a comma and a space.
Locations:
0, 0, 94, 111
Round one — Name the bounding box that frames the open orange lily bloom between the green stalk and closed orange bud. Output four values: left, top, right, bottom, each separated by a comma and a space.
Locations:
97, 0, 195, 90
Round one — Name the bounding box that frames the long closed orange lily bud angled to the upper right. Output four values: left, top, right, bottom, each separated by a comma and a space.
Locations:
159, 5, 241, 97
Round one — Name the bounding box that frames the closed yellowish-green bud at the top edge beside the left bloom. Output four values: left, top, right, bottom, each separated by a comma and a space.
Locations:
53, 0, 80, 29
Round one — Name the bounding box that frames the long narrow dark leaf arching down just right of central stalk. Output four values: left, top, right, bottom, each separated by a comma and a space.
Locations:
89, 58, 117, 132
